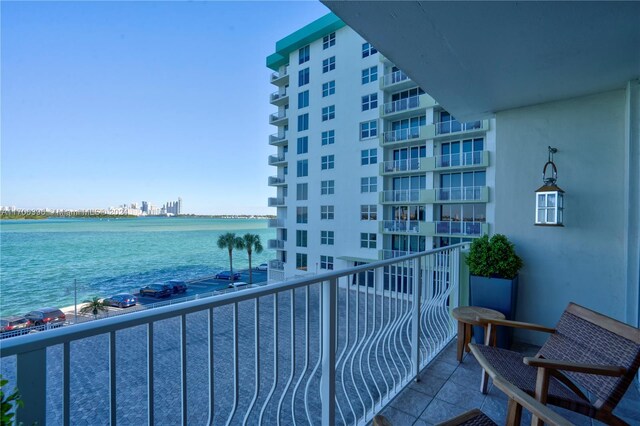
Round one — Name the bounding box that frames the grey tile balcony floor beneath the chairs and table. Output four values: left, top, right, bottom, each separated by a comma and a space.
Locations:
381, 341, 640, 426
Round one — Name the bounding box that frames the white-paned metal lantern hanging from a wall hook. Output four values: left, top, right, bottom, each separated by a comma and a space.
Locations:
535, 147, 564, 226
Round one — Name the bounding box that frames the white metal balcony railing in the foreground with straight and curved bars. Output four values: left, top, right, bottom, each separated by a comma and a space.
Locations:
1, 245, 461, 425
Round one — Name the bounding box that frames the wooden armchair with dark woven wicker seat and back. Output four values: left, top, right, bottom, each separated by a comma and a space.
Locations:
470, 303, 640, 425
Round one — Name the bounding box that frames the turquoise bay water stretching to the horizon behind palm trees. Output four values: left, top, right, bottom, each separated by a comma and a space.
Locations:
0, 218, 275, 316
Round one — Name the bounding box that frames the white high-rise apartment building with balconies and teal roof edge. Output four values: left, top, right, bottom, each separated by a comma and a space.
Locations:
267, 13, 495, 280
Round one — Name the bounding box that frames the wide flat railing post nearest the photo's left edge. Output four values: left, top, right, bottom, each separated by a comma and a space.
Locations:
16, 349, 47, 425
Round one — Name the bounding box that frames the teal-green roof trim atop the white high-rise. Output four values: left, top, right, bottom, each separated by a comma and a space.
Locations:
267, 13, 346, 71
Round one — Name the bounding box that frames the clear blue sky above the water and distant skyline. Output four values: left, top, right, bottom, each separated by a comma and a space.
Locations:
0, 1, 329, 214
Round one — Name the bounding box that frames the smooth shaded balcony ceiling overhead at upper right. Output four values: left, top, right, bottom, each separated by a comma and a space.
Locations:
323, 0, 640, 120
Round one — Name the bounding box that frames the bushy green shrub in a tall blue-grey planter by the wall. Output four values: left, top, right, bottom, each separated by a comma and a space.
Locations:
467, 234, 522, 347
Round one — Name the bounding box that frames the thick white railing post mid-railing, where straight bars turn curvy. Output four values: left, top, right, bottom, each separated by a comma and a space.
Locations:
320, 278, 338, 426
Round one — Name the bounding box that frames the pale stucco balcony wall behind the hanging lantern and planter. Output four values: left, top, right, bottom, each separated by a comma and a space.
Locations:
495, 90, 627, 342
